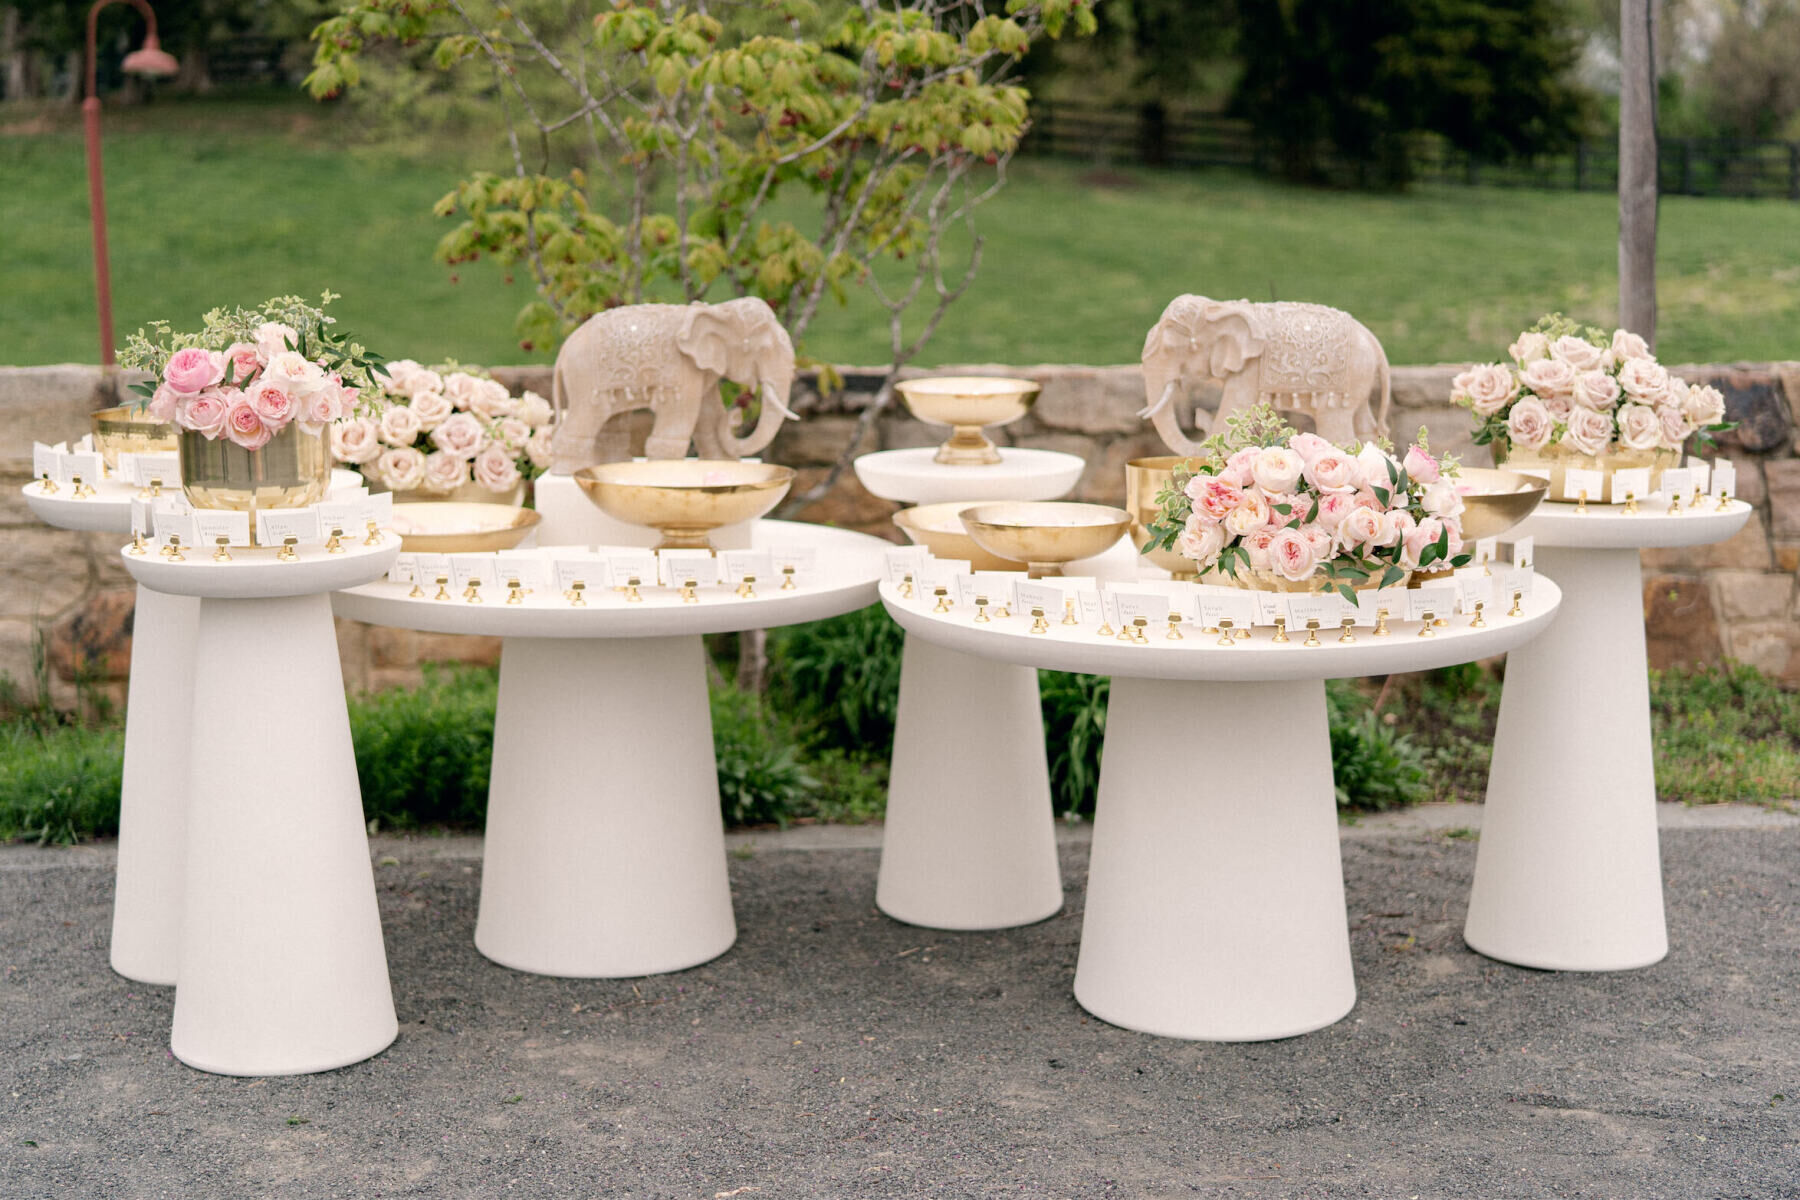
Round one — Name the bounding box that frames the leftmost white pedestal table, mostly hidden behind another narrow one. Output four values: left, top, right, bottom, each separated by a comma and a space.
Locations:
22, 470, 362, 986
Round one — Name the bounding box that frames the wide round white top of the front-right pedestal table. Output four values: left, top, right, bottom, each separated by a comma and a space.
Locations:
880, 576, 1562, 682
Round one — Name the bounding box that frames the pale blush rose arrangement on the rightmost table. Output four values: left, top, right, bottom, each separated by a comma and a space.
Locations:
1451, 313, 1733, 500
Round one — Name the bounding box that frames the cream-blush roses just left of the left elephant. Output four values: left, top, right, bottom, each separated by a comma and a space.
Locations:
331, 358, 553, 504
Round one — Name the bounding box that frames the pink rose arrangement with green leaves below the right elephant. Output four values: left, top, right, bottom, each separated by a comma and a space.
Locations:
1145, 405, 1471, 601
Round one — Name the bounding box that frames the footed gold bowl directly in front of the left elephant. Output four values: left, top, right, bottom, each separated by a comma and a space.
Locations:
574, 459, 794, 551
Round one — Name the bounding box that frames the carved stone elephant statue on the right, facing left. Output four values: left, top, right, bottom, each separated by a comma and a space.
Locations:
1138, 295, 1391, 455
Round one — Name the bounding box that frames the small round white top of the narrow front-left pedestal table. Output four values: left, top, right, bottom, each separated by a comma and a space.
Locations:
119, 529, 400, 599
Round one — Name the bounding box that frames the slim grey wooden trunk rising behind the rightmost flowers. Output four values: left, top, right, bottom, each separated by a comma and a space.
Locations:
1618, 0, 1658, 347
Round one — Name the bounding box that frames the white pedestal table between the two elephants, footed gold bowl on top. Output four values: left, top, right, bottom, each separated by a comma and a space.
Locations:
853, 446, 1087, 930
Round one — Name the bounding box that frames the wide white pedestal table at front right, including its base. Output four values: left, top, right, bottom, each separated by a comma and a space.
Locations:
882, 579, 1561, 1042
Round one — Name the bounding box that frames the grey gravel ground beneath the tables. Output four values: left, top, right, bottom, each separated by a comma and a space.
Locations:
0, 820, 1800, 1200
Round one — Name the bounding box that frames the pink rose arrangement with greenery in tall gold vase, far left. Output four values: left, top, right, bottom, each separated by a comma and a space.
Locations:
119, 291, 382, 511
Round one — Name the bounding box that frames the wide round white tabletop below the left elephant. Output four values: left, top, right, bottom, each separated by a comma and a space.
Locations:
331, 520, 893, 637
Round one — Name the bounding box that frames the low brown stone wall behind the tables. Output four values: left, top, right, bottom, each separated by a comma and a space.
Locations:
0, 363, 1800, 705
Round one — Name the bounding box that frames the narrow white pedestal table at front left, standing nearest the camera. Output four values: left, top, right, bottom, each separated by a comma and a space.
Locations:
121, 533, 400, 1076
